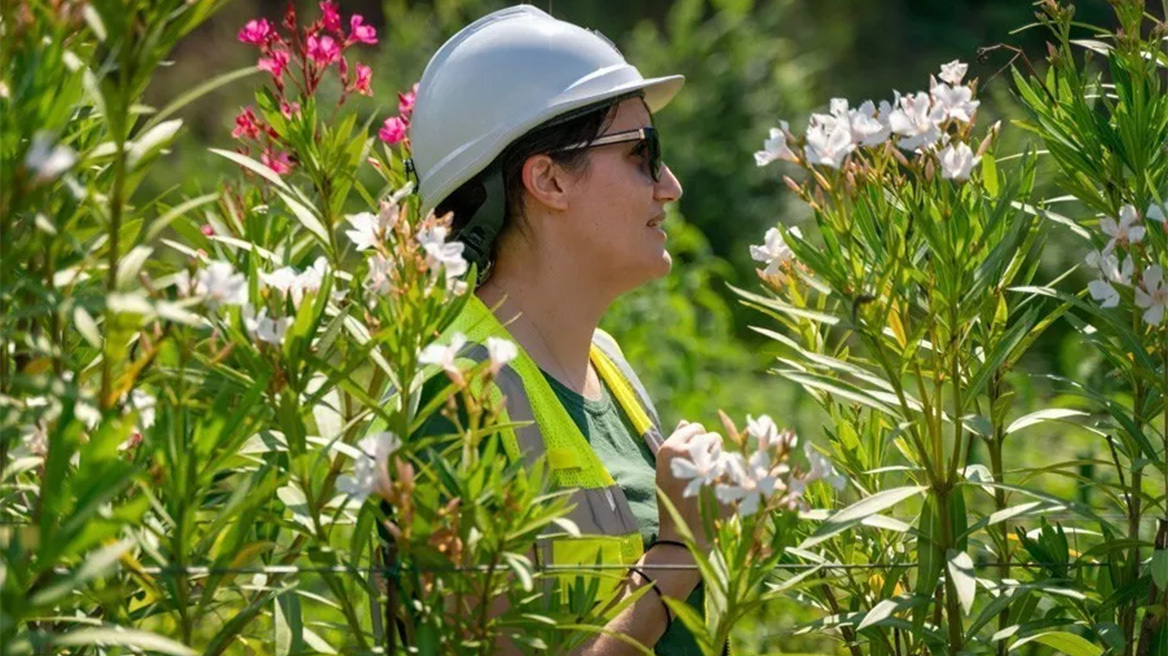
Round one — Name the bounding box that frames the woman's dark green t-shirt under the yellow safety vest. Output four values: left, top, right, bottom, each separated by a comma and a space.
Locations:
543, 372, 702, 656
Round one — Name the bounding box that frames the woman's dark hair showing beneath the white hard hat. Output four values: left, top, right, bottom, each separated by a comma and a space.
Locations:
434, 93, 639, 266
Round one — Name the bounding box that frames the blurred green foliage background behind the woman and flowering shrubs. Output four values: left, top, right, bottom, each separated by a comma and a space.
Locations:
141, 0, 1161, 654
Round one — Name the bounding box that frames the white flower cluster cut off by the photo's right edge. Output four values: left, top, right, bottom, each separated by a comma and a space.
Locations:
1086, 203, 1168, 326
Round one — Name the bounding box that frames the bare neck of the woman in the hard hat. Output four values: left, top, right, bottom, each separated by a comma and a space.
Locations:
475, 250, 612, 399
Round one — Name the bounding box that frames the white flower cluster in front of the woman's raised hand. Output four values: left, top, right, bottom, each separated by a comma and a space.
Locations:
672, 414, 847, 517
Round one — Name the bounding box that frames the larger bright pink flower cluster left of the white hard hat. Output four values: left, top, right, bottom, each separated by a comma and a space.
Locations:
231, 0, 377, 175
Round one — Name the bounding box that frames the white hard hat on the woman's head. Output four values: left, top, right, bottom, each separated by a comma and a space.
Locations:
410, 5, 686, 212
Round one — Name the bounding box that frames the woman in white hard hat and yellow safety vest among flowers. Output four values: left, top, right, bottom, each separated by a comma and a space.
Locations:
410, 6, 719, 654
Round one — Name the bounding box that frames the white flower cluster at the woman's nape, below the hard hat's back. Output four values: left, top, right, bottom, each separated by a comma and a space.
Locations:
345, 186, 468, 295
